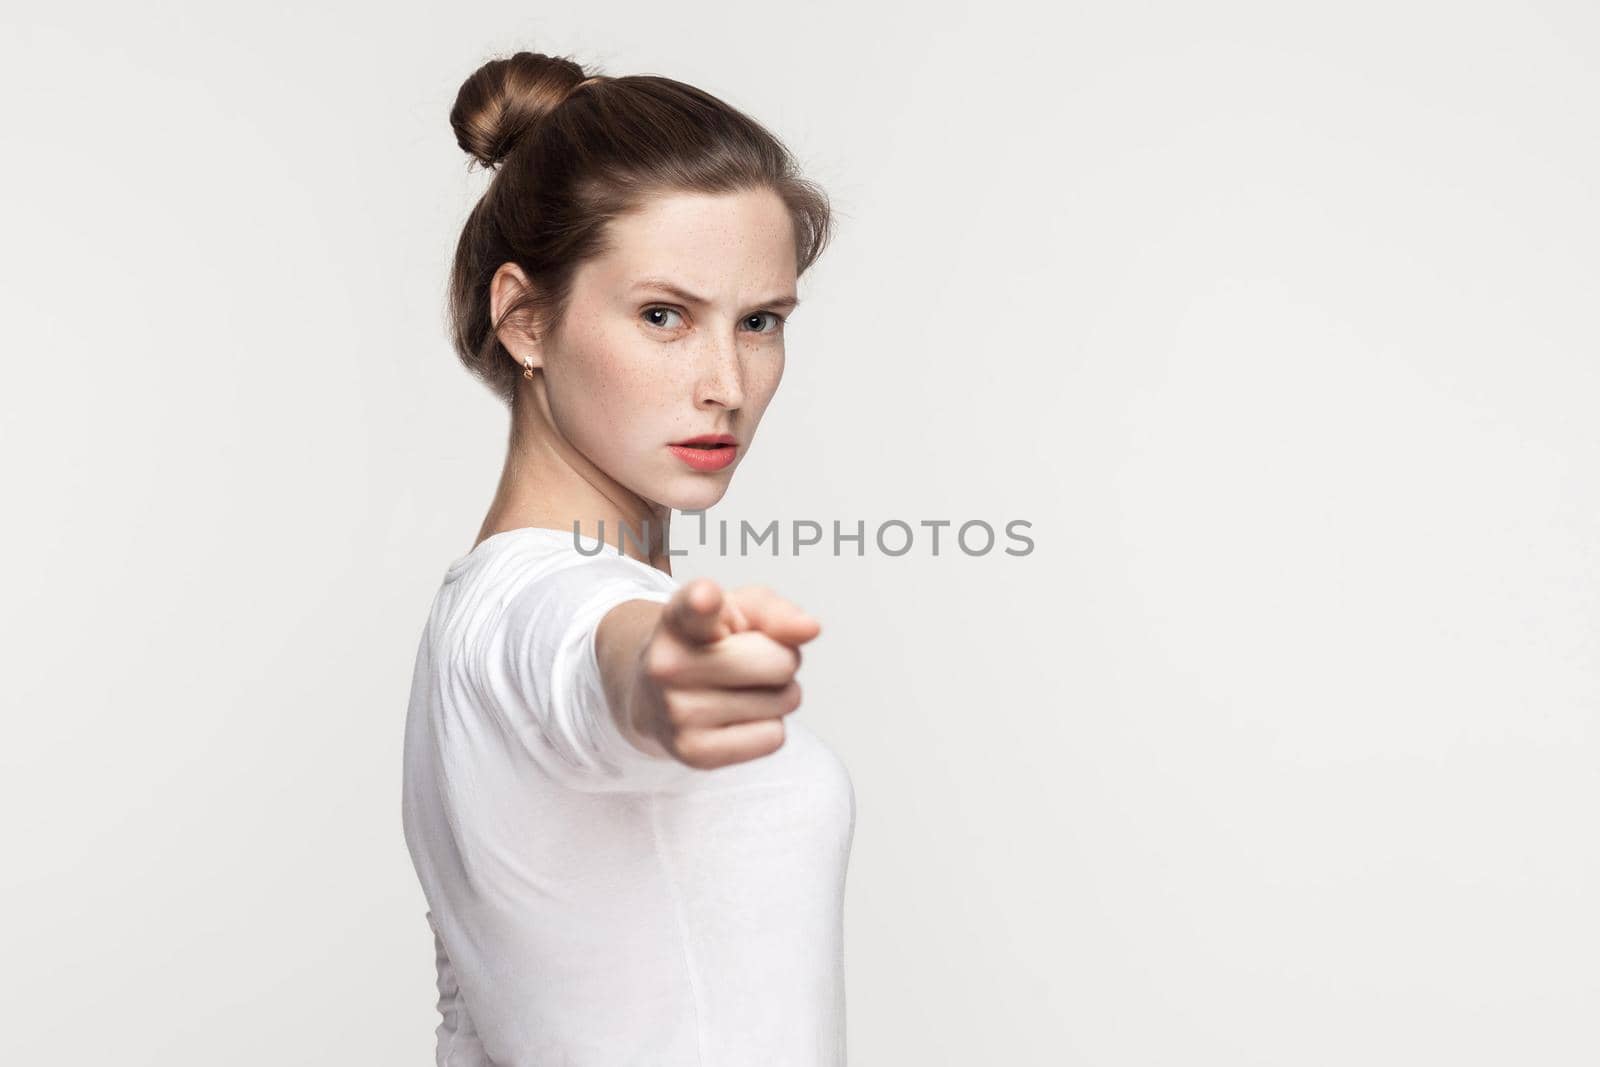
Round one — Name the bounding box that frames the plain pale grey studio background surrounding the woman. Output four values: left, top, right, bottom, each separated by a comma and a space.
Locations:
0, 2, 1600, 1067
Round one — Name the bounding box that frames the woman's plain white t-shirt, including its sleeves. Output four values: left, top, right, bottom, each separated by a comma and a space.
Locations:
402, 526, 856, 1067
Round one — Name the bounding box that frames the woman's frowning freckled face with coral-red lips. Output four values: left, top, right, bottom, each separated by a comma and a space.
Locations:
515, 189, 795, 510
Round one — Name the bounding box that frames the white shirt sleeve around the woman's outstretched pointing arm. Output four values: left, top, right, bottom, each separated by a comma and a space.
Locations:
480, 555, 694, 792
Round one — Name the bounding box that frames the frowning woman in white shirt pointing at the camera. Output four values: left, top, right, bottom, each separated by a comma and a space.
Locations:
403, 53, 854, 1067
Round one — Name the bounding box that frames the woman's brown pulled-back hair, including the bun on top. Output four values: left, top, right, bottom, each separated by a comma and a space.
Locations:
450, 51, 832, 403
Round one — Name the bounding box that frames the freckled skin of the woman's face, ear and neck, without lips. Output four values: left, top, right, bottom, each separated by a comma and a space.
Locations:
478, 189, 797, 573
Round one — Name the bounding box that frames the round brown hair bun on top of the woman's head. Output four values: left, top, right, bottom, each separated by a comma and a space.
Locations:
450, 51, 584, 166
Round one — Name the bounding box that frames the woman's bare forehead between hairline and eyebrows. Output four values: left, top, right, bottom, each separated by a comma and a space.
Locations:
586, 189, 795, 298
